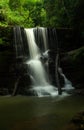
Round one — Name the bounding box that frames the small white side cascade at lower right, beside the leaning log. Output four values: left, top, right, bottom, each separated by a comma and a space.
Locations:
58, 67, 74, 92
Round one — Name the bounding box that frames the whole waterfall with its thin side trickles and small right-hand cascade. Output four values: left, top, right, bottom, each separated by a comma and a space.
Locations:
13, 27, 74, 97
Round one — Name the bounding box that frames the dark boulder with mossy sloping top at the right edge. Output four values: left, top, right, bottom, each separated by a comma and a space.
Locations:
61, 46, 84, 88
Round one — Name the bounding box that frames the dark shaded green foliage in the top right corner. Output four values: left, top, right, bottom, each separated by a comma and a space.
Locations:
44, 0, 84, 27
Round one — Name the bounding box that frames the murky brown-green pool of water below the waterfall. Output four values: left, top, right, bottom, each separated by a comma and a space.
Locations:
0, 96, 84, 130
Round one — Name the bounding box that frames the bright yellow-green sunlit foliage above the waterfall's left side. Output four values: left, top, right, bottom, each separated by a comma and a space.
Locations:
0, 0, 46, 27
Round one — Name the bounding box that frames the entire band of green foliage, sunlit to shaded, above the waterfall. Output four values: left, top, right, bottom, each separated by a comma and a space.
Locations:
0, 0, 84, 28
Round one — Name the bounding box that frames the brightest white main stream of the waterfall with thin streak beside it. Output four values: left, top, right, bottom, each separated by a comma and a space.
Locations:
25, 28, 58, 97
